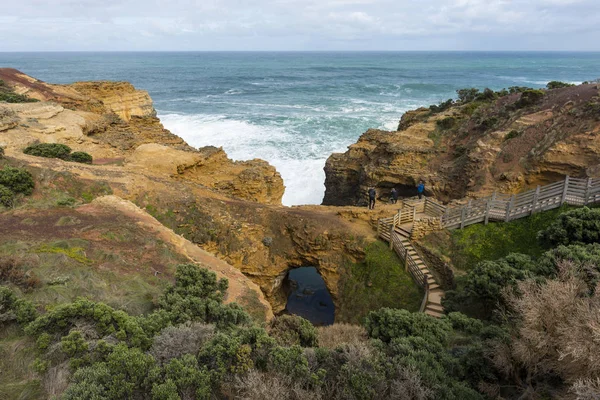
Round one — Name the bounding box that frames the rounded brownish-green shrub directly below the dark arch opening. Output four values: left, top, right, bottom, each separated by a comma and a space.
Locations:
269, 315, 318, 347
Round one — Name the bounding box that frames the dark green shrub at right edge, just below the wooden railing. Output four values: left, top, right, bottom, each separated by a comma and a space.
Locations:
538, 207, 600, 247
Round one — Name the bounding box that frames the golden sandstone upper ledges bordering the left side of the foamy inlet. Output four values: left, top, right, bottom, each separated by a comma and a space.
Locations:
0, 69, 284, 204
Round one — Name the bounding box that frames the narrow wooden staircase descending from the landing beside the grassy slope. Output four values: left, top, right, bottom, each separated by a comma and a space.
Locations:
394, 223, 444, 318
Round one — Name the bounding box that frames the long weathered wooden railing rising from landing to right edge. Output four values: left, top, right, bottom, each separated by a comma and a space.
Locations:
440, 176, 600, 229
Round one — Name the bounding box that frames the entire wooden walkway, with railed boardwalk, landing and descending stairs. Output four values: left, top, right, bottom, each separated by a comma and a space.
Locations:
377, 176, 600, 318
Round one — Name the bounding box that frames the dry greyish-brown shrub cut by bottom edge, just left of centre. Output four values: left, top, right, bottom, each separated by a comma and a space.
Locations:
232, 370, 322, 400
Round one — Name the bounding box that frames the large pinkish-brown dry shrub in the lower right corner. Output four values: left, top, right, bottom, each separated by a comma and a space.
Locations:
494, 262, 600, 384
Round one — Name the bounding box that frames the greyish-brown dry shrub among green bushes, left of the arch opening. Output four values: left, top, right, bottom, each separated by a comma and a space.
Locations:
150, 322, 215, 364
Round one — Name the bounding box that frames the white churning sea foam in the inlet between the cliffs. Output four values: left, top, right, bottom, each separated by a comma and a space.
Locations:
159, 113, 347, 205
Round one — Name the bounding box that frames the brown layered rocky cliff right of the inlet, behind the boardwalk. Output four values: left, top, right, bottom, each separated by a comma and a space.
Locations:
323, 84, 600, 205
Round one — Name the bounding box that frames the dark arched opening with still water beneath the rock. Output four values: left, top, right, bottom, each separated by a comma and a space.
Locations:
284, 267, 335, 326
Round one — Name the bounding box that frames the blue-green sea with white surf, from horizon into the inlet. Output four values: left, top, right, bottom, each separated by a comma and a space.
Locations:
0, 52, 600, 205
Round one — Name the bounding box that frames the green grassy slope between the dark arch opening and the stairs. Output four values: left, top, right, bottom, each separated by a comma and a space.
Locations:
336, 241, 423, 323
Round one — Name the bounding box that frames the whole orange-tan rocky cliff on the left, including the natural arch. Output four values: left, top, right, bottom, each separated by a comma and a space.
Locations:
0, 70, 374, 314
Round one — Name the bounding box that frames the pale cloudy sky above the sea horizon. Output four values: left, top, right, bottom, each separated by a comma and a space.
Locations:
0, 0, 600, 51
